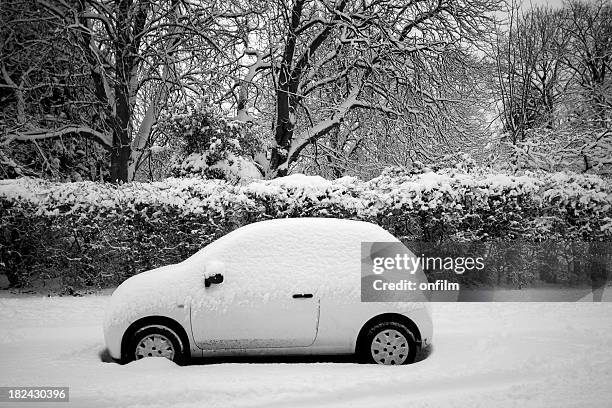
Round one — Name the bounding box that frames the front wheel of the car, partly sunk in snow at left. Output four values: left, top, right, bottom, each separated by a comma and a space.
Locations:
126, 325, 187, 364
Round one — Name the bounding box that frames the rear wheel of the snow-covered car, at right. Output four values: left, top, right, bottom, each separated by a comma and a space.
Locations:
359, 322, 417, 365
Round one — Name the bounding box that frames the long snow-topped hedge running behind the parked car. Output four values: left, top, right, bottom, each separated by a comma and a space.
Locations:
0, 170, 612, 286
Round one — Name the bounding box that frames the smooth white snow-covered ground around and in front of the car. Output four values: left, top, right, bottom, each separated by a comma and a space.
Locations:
0, 294, 612, 408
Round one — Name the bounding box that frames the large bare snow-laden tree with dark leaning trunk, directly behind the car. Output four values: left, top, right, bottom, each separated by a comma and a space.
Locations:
237, 0, 499, 177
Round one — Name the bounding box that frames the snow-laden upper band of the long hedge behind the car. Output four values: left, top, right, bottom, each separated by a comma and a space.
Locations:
0, 169, 612, 234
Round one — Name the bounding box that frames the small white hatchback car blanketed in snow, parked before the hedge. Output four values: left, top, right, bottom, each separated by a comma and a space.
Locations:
104, 218, 433, 365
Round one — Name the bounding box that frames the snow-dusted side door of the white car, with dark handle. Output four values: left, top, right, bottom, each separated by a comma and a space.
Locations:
191, 223, 319, 350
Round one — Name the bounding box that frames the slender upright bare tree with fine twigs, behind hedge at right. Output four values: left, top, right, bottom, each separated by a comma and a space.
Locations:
495, 2, 569, 144
